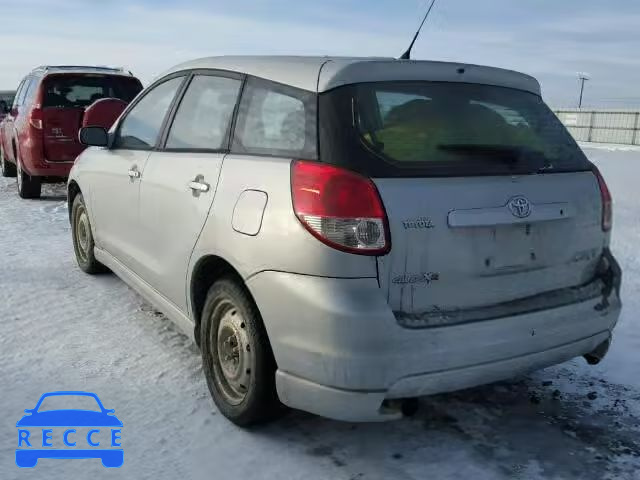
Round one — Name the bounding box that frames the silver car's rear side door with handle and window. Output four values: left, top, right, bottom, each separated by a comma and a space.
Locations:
136, 71, 243, 313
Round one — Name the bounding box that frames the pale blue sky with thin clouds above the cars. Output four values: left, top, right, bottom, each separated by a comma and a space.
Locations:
0, 0, 640, 108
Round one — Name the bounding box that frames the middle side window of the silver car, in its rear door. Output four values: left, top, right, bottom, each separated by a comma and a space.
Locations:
166, 75, 242, 150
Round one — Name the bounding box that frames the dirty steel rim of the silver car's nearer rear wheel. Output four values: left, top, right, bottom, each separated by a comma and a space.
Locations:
211, 300, 251, 405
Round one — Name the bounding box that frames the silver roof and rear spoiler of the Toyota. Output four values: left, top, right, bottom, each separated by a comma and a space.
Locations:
163, 56, 540, 95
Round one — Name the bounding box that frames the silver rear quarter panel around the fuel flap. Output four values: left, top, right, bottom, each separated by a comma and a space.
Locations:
187, 155, 377, 314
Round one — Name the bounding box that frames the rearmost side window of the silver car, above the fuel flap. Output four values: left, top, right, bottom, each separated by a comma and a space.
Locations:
232, 78, 317, 159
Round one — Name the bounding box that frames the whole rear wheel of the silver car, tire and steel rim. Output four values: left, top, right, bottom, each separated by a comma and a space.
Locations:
200, 277, 285, 427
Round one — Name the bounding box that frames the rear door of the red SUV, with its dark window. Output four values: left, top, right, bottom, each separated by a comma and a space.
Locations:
41, 73, 142, 162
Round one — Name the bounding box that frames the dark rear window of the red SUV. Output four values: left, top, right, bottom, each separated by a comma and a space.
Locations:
42, 74, 142, 108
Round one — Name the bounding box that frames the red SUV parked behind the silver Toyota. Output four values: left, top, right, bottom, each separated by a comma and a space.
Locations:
0, 66, 142, 198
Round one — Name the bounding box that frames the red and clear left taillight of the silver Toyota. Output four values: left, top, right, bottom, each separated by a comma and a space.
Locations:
291, 160, 391, 255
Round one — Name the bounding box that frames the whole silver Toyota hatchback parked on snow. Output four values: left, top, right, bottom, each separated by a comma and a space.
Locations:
68, 57, 621, 425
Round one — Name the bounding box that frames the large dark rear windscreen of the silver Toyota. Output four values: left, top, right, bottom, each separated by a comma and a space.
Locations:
320, 82, 590, 176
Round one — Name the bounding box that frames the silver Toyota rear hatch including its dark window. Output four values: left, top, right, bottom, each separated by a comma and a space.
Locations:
320, 81, 608, 327
